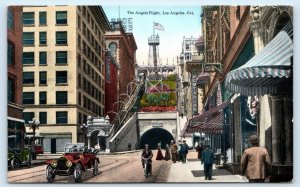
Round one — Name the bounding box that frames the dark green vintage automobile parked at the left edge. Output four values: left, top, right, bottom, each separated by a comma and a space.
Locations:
7, 147, 31, 169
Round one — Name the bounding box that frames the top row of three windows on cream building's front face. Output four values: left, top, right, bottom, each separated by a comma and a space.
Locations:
22, 11, 68, 26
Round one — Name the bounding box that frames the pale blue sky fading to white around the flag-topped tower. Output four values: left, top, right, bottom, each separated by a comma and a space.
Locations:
102, 5, 201, 65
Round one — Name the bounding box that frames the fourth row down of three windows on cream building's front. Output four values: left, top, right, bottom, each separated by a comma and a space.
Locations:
23, 71, 68, 85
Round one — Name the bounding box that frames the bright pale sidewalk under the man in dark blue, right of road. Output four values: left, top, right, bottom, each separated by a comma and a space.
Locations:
167, 150, 248, 183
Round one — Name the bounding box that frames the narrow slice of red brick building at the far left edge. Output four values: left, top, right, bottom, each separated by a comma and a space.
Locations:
7, 6, 25, 148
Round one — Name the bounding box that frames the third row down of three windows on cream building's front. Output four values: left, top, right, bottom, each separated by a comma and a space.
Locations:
22, 51, 68, 65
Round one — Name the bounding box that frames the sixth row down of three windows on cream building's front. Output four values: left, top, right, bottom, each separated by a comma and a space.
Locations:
23, 111, 68, 124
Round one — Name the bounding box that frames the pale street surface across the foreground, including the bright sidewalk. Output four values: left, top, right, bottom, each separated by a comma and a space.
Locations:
8, 150, 247, 183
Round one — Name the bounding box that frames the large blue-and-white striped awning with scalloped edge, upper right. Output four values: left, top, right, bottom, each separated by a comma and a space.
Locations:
225, 23, 293, 96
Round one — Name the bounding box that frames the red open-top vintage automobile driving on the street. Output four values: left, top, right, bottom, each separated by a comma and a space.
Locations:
46, 143, 100, 182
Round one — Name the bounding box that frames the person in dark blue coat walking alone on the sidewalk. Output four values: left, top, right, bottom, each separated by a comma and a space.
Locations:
201, 145, 214, 180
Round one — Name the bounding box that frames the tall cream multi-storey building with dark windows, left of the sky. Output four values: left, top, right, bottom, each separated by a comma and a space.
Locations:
22, 6, 109, 153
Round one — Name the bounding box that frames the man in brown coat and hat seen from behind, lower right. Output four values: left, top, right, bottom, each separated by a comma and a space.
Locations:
241, 135, 271, 183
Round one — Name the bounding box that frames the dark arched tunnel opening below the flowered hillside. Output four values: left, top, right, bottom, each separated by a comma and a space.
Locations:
140, 128, 174, 149
